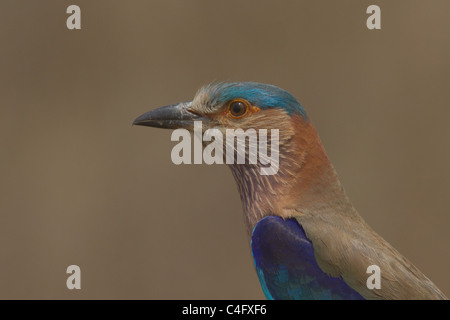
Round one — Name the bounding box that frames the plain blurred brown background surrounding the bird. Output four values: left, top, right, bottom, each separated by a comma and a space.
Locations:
0, 0, 450, 299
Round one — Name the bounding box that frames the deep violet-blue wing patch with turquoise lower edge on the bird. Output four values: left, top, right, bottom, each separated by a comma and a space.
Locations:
252, 216, 364, 300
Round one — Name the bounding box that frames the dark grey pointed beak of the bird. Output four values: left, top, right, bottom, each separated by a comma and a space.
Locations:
133, 101, 206, 130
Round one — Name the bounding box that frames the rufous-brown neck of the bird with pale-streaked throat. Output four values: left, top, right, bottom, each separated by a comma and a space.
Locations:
230, 115, 356, 235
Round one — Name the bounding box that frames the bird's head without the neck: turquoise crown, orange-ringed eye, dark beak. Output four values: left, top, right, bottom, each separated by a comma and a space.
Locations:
133, 82, 307, 135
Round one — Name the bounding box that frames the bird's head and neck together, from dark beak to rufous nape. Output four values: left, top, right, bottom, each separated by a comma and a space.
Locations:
133, 82, 344, 231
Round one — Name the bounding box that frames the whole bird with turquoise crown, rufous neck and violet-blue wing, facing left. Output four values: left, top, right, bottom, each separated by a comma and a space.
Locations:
133, 82, 447, 300
